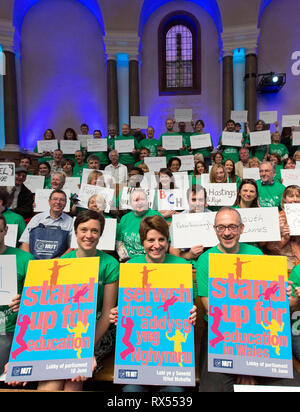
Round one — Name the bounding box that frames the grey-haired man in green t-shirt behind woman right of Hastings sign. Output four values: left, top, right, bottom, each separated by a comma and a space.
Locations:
256, 161, 285, 207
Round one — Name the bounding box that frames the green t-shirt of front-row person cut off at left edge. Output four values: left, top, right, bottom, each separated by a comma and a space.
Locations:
0, 246, 34, 333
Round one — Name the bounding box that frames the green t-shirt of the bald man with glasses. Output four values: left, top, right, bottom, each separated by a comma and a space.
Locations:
196, 243, 263, 312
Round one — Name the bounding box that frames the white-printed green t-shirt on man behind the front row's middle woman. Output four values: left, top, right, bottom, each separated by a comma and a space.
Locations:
116, 209, 161, 258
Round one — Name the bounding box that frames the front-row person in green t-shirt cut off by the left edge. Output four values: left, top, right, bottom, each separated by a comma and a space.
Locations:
0, 215, 34, 375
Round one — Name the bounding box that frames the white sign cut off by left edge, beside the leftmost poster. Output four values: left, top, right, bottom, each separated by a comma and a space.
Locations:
0, 255, 18, 305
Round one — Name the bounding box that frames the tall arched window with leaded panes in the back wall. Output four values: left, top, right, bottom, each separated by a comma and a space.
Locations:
158, 11, 201, 95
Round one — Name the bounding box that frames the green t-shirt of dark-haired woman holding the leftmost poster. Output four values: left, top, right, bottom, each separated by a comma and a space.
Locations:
60, 250, 120, 314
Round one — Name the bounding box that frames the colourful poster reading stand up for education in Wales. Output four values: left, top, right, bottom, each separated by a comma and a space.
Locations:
208, 253, 293, 378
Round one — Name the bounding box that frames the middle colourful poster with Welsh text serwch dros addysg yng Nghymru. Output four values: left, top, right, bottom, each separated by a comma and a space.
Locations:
114, 264, 195, 386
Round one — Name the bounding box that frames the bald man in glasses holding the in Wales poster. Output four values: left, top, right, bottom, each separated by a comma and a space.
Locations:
196, 207, 263, 392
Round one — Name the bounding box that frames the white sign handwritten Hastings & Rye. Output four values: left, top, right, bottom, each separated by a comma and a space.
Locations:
202, 183, 237, 206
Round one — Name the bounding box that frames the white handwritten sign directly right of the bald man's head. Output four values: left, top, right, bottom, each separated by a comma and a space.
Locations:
238, 207, 281, 243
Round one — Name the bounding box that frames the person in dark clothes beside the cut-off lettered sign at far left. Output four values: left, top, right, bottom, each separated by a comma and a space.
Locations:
7, 167, 34, 219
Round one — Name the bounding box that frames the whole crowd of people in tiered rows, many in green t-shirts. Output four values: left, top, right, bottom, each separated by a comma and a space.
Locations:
0, 119, 300, 391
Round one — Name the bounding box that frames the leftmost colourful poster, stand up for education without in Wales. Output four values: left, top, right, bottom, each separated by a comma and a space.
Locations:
6, 257, 99, 382
